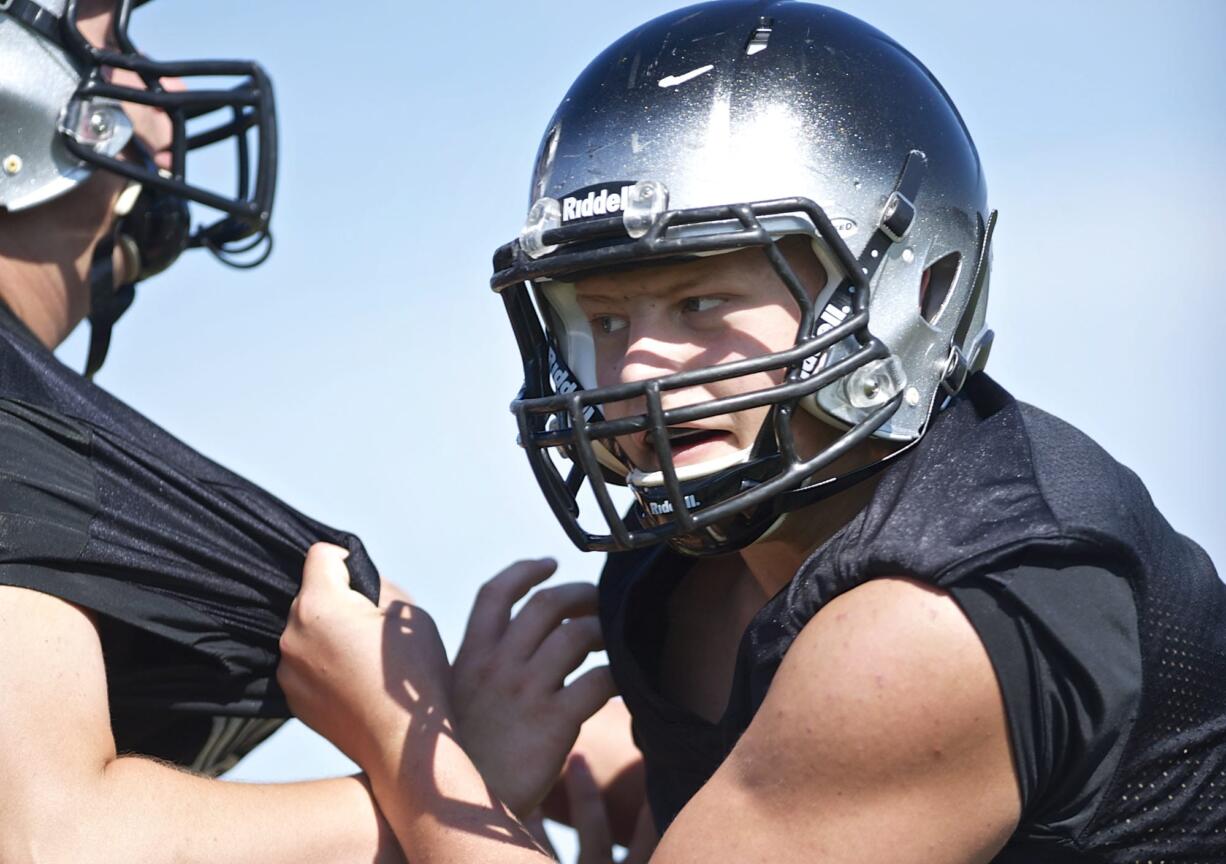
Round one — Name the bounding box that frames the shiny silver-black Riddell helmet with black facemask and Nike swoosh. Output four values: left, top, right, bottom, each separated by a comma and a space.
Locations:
492, 0, 994, 554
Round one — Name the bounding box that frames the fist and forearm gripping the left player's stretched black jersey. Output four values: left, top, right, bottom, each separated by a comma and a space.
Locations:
277, 553, 550, 864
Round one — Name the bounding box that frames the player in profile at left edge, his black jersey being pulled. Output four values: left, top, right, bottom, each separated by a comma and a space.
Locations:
0, 0, 609, 863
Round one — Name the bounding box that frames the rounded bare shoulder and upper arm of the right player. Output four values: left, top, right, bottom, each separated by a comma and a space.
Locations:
652, 580, 1021, 864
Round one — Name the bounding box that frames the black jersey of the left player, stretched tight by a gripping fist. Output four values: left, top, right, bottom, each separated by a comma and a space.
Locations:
0, 297, 379, 773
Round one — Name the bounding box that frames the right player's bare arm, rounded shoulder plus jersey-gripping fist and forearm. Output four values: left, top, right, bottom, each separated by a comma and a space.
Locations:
280, 550, 1020, 864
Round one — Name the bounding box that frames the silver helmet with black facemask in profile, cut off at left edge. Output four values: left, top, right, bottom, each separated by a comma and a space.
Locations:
0, 0, 277, 373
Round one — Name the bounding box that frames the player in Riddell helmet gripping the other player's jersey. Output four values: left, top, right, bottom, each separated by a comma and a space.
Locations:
281, 0, 1226, 863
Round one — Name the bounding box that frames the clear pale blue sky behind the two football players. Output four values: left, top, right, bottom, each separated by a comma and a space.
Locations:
61, 0, 1226, 852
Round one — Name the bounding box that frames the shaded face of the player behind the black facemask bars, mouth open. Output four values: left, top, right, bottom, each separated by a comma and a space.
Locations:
576, 237, 826, 472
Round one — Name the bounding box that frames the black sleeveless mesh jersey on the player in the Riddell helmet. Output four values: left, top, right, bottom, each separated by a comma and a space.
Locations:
601, 374, 1226, 864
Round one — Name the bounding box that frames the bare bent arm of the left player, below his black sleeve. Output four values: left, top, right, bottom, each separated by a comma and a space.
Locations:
0, 587, 402, 864
